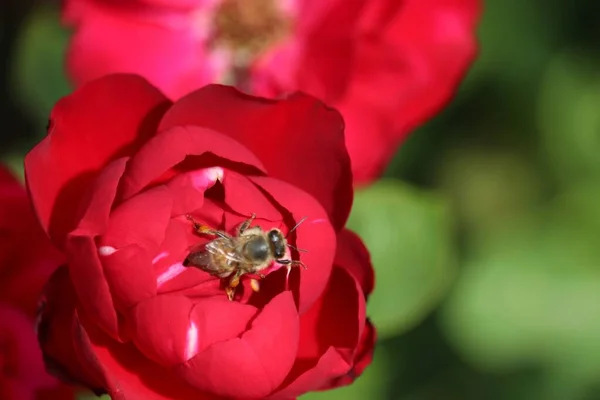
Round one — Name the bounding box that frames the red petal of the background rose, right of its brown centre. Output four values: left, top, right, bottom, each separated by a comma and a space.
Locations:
342, 0, 480, 183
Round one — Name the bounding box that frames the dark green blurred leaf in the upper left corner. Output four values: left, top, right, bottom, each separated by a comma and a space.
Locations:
12, 6, 71, 132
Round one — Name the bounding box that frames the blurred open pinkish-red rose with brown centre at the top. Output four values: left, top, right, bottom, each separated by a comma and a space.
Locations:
64, 0, 480, 183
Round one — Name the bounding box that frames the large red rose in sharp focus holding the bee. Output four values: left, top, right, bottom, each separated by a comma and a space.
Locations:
25, 75, 375, 400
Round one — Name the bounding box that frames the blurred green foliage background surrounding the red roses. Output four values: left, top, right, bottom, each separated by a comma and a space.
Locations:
0, 0, 600, 400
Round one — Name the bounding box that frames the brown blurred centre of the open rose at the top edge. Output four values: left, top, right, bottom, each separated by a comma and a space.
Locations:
214, 0, 291, 58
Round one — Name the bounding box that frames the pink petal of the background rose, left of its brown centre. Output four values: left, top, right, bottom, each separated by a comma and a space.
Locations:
65, 0, 218, 99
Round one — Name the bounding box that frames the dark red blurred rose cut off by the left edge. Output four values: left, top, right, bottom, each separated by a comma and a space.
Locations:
0, 166, 74, 400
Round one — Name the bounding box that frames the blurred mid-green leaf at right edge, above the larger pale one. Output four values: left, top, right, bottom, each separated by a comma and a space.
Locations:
537, 52, 600, 182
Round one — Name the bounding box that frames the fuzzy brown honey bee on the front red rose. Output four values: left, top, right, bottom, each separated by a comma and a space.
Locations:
183, 214, 306, 301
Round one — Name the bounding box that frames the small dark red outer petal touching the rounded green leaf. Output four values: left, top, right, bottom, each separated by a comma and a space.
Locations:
334, 229, 375, 297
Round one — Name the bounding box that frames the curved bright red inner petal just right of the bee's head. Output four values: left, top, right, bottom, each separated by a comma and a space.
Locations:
251, 177, 336, 314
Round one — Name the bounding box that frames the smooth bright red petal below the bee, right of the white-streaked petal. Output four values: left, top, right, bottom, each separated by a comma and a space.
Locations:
179, 292, 298, 399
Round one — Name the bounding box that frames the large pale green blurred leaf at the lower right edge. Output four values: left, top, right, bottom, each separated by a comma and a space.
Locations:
442, 188, 600, 382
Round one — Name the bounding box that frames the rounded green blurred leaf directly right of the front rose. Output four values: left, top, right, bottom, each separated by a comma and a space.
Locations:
348, 180, 455, 337
